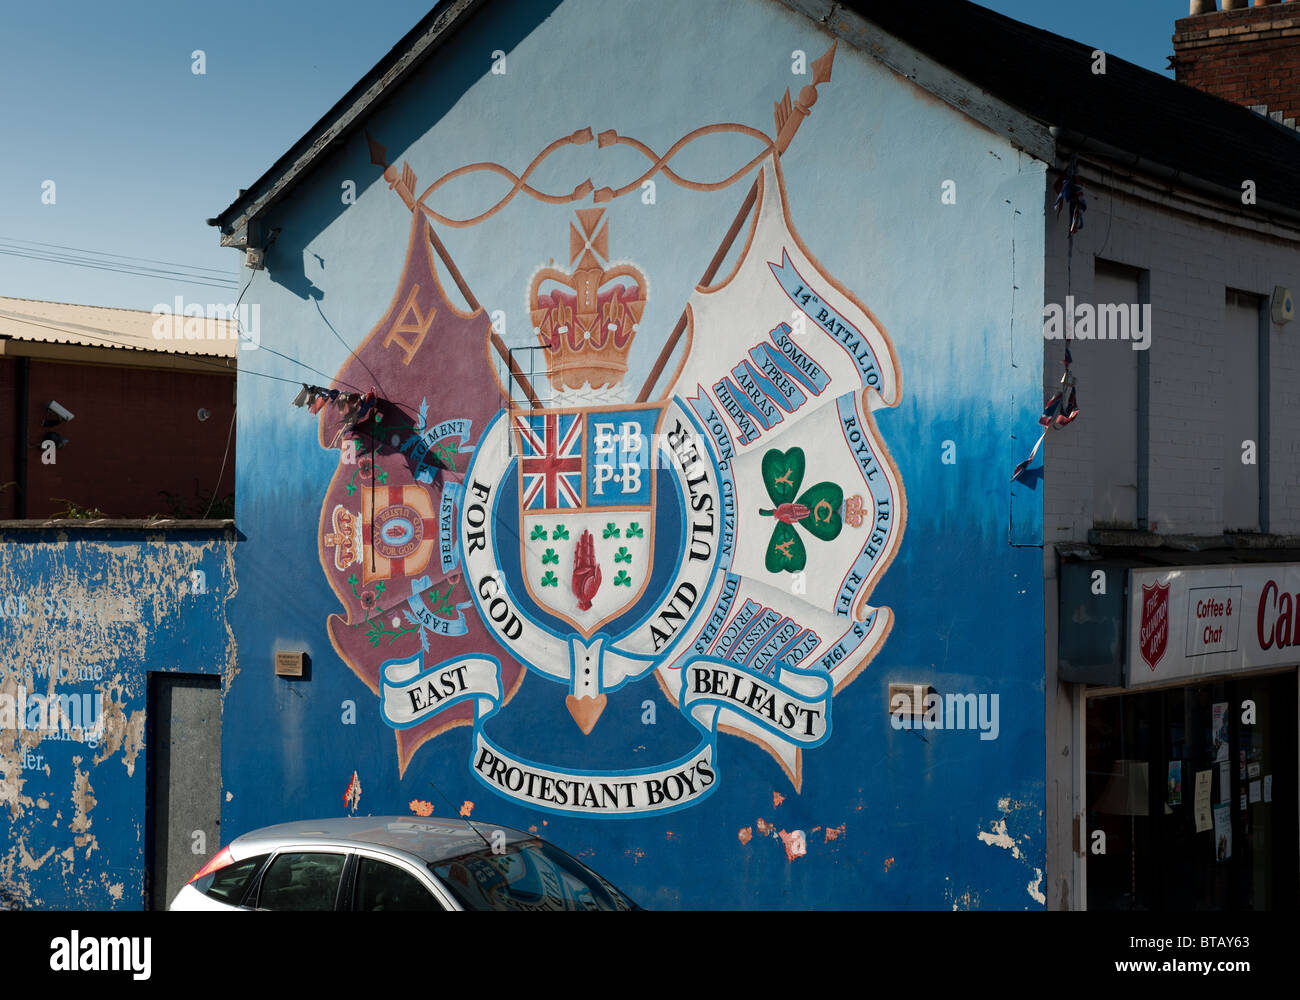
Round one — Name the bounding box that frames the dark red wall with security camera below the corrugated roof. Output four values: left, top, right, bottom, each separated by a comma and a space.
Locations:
0, 359, 235, 518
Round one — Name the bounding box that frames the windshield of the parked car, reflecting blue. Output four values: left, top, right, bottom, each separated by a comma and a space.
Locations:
429, 840, 637, 910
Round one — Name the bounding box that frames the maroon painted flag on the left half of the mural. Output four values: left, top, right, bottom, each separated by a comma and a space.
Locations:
312, 208, 523, 770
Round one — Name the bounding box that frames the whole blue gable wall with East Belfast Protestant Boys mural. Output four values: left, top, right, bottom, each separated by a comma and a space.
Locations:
222, 0, 1044, 908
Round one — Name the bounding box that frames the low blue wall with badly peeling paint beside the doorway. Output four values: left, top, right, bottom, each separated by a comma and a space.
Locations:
0, 527, 235, 909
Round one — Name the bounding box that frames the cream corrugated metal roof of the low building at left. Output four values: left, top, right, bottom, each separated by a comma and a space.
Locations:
0, 296, 239, 358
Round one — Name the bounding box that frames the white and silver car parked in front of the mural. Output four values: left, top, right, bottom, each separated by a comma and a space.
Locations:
168, 817, 640, 910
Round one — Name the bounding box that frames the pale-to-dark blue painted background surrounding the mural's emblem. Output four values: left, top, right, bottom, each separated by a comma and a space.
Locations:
222, 0, 1045, 908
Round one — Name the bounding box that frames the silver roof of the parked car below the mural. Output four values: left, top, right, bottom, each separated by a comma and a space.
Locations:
230, 815, 536, 862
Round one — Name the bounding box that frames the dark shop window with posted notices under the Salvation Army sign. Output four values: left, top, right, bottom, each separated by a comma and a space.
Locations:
1084, 671, 1297, 912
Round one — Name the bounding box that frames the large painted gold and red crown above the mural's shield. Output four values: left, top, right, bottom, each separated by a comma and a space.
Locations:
528, 208, 646, 391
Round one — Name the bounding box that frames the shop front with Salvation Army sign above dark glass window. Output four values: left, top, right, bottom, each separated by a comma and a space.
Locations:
1061, 563, 1300, 912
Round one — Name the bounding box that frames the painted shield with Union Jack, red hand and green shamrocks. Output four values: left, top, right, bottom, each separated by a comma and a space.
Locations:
511, 404, 663, 638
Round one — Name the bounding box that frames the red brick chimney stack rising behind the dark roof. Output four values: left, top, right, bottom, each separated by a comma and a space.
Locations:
1170, 0, 1300, 129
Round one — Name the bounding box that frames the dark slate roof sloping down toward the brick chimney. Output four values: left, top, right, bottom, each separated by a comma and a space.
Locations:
844, 0, 1300, 212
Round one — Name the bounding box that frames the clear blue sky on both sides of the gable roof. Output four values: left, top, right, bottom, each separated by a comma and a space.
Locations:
0, 0, 1188, 309
